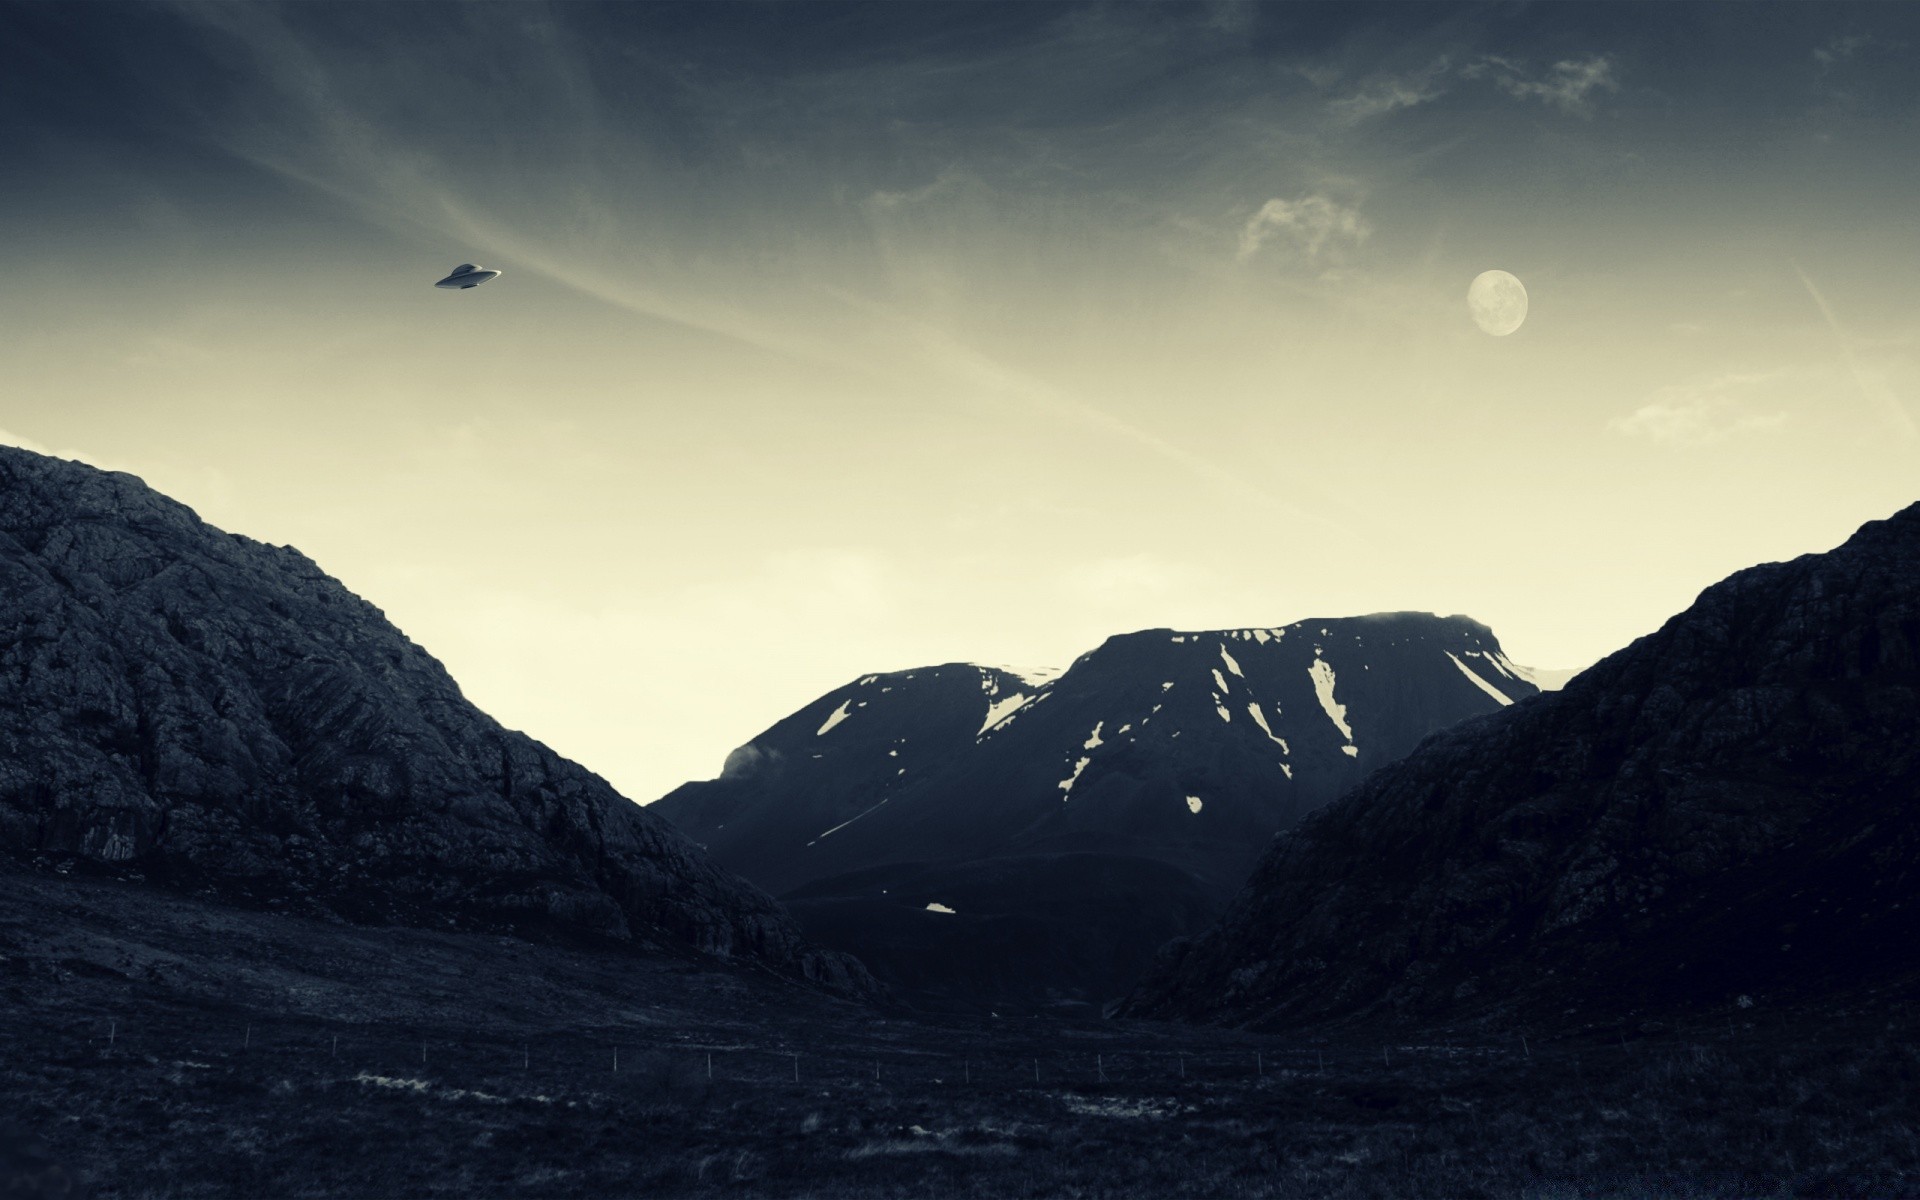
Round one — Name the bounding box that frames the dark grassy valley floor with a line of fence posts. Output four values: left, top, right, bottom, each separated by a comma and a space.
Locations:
0, 868, 1920, 1198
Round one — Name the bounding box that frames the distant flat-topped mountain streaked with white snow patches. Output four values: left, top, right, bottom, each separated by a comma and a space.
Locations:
651, 612, 1538, 1006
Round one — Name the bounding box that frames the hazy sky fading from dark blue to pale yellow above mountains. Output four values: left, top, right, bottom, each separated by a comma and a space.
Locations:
0, 0, 1920, 803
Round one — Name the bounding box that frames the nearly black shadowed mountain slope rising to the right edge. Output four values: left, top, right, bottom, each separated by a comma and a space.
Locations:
1125, 505, 1920, 1025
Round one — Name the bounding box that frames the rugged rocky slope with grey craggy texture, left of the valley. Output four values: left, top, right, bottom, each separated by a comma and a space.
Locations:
0, 447, 870, 991
